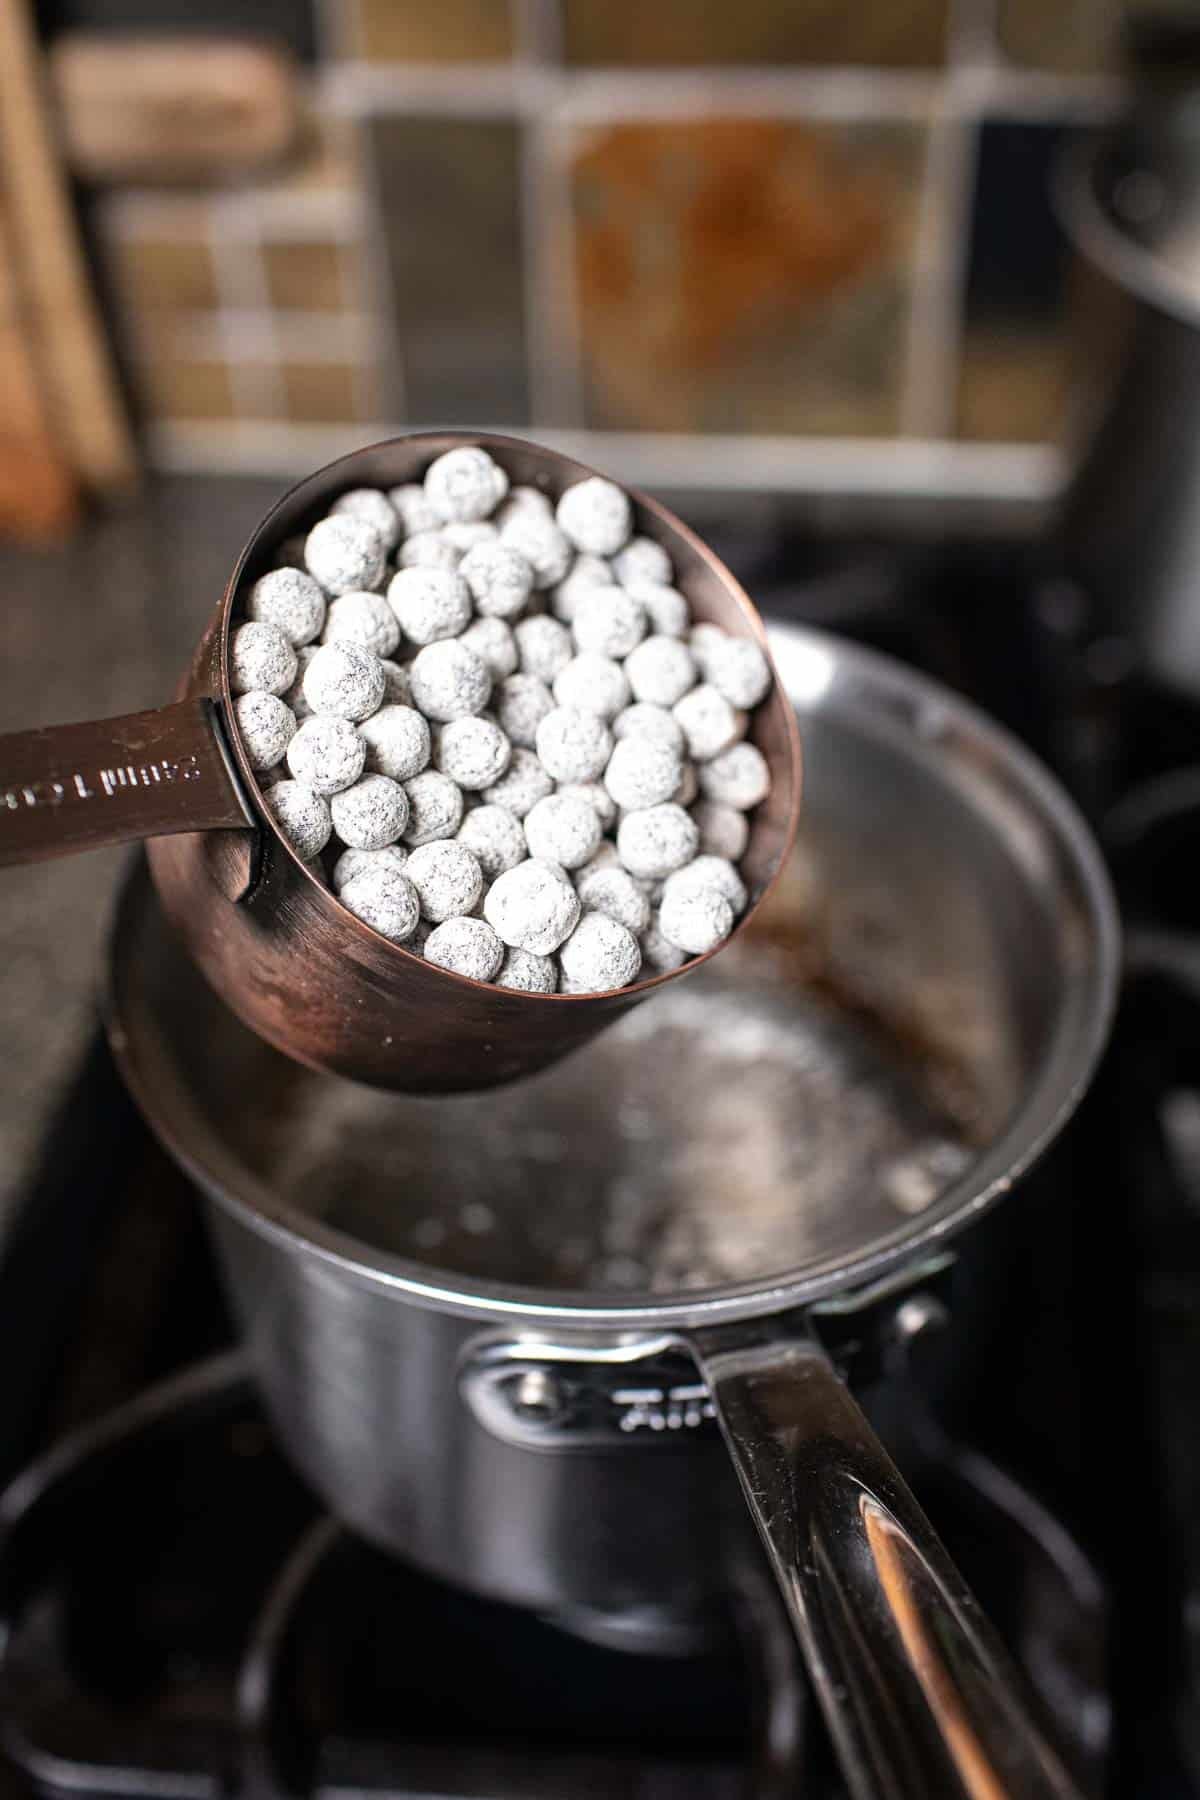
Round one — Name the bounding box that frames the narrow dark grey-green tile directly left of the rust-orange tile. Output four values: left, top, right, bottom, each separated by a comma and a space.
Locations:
372, 119, 529, 425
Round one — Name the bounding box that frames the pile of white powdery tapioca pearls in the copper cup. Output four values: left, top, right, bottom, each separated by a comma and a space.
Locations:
230, 448, 770, 994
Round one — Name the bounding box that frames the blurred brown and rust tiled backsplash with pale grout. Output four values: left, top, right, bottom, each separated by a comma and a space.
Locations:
89, 0, 1139, 491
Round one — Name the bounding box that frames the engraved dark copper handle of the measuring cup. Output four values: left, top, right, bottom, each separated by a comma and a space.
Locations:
0, 697, 254, 866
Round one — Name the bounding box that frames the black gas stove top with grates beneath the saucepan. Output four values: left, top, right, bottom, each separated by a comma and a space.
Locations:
0, 525, 1200, 1800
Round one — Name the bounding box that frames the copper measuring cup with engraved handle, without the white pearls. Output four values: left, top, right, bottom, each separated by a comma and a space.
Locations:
0, 432, 801, 1093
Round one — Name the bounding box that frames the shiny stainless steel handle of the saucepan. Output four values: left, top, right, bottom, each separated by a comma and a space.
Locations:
693, 1334, 1076, 1800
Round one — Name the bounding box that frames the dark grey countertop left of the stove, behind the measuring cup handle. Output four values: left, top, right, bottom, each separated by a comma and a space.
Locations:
0, 477, 286, 1229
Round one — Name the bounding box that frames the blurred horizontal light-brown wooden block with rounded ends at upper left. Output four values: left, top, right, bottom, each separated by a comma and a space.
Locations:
50, 32, 299, 182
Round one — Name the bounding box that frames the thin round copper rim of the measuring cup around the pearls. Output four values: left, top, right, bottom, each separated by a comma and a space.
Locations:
216, 430, 802, 1006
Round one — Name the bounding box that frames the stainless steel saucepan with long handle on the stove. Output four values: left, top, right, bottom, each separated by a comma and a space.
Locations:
112, 628, 1117, 1800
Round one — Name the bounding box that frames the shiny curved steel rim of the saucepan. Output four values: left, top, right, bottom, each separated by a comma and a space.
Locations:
108, 625, 1121, 1334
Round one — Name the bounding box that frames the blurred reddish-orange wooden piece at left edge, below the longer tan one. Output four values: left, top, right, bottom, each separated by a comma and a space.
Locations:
0, 196, 79, 538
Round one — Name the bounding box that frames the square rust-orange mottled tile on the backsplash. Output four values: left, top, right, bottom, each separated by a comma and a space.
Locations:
574, 119, 925, 434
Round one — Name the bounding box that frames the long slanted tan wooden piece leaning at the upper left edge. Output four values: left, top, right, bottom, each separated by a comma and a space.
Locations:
0, 0, 137, 514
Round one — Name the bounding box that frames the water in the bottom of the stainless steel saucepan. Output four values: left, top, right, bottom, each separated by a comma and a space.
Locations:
255, 860, 997, 1294
